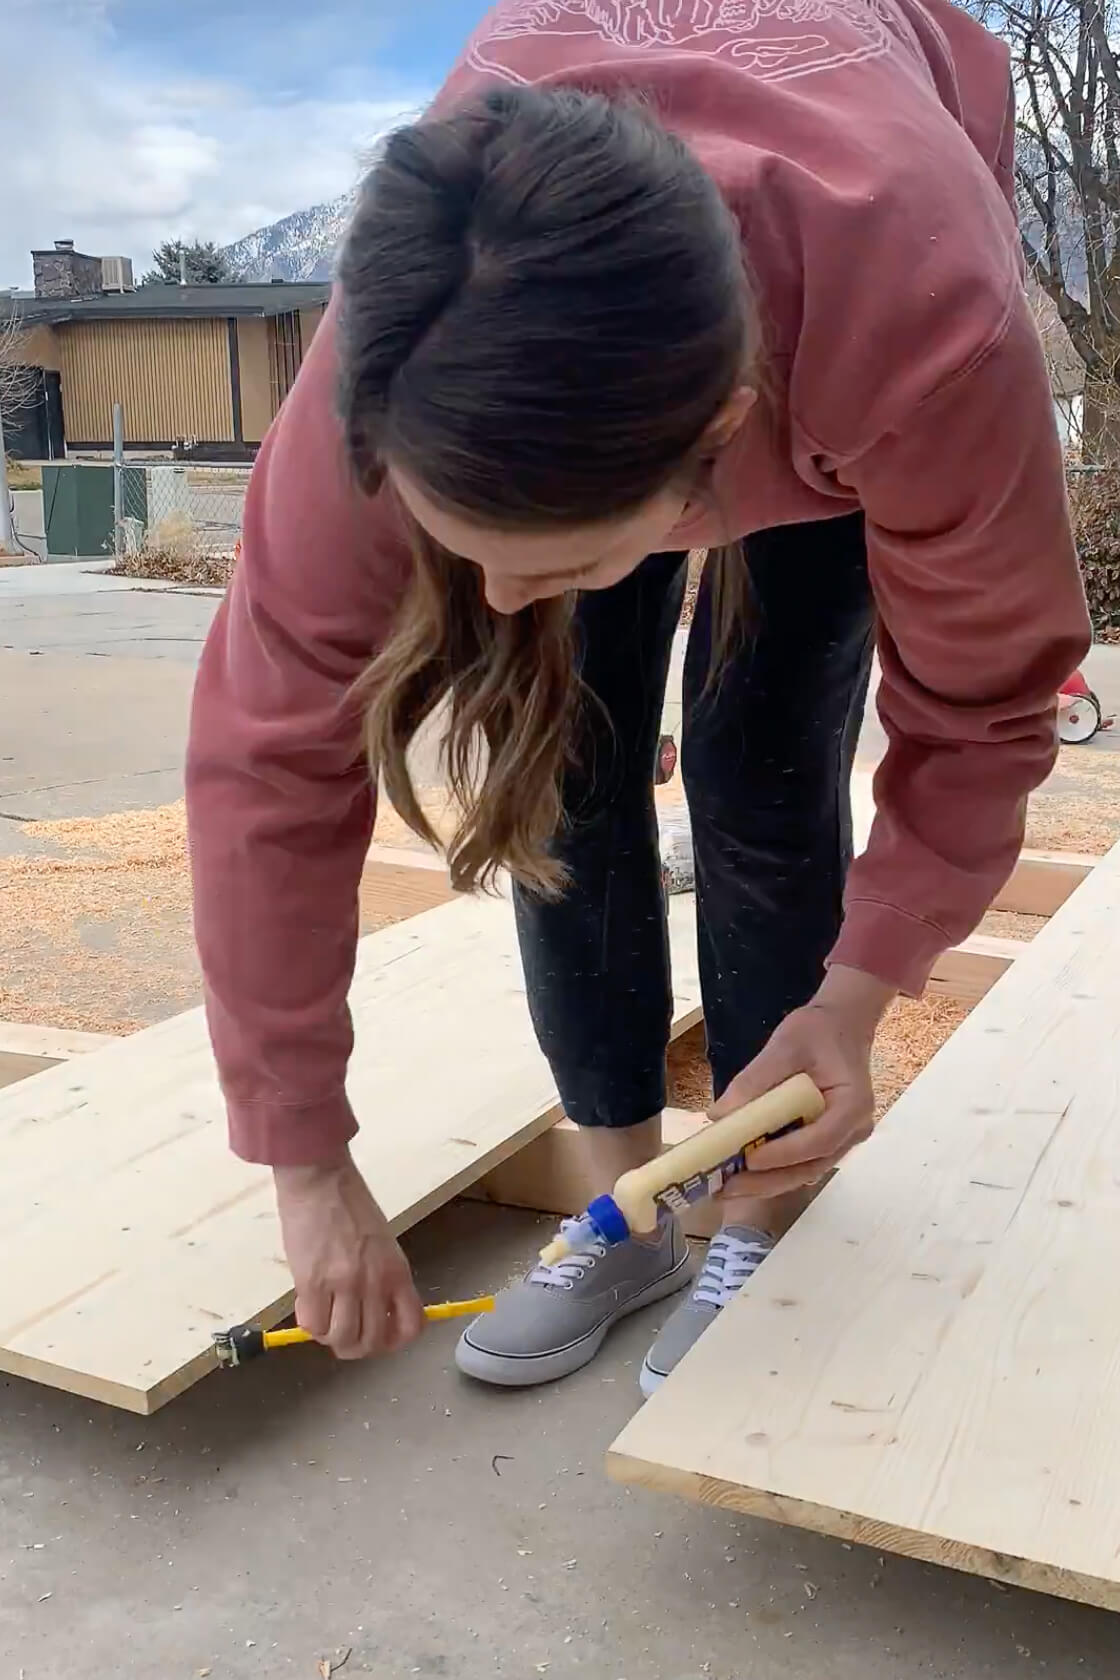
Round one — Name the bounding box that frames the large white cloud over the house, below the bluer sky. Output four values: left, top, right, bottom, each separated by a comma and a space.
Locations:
0, 0, 428, 286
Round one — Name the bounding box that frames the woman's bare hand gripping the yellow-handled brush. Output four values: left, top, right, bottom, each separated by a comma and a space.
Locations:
272, 1151, 425, 1359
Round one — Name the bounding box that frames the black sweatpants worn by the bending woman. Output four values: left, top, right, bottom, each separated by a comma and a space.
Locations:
516, 516, 873, 1126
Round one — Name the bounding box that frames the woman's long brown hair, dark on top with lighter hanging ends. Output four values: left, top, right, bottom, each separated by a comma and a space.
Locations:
339, 87, 754, 894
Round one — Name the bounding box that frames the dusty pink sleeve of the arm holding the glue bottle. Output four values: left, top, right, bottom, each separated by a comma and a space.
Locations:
831, 291, 1090, 995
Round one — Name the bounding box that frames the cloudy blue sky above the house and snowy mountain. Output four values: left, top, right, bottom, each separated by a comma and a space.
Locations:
0, 0, 485, 286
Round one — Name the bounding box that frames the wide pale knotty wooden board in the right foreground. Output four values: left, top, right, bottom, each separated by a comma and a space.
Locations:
610, 848, 1120, 1609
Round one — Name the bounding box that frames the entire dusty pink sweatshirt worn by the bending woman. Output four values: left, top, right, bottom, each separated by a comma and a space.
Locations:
188, 0, 1088, 1164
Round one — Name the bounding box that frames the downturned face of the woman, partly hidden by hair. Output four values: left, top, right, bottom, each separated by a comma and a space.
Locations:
390, 467, 687, 613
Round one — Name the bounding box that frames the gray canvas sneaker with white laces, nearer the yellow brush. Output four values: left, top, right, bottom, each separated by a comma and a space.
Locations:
455, 1218, 692, 1388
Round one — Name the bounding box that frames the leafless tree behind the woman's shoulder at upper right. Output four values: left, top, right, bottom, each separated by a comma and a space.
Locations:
972, 0, 1120, 464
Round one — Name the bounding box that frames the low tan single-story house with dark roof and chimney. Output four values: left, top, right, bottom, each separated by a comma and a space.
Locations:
0, 240, 331, 460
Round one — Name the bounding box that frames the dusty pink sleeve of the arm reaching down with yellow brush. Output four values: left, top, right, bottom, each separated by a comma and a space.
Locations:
186, 311, 406, 1164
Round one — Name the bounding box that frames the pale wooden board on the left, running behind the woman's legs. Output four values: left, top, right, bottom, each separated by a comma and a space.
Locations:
0, 899, 700, 1413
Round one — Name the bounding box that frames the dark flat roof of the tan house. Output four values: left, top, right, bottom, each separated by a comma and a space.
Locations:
0, 281, 331, 326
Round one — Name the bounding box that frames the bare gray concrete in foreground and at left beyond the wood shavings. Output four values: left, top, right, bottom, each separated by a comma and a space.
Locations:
0, 568, 1120, 1680
